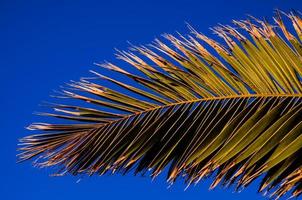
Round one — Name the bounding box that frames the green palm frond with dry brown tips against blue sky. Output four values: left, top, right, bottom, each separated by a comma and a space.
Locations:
19, 11, 302, 198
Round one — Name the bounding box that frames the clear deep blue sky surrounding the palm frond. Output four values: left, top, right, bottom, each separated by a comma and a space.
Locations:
0, 0, 302, 200
